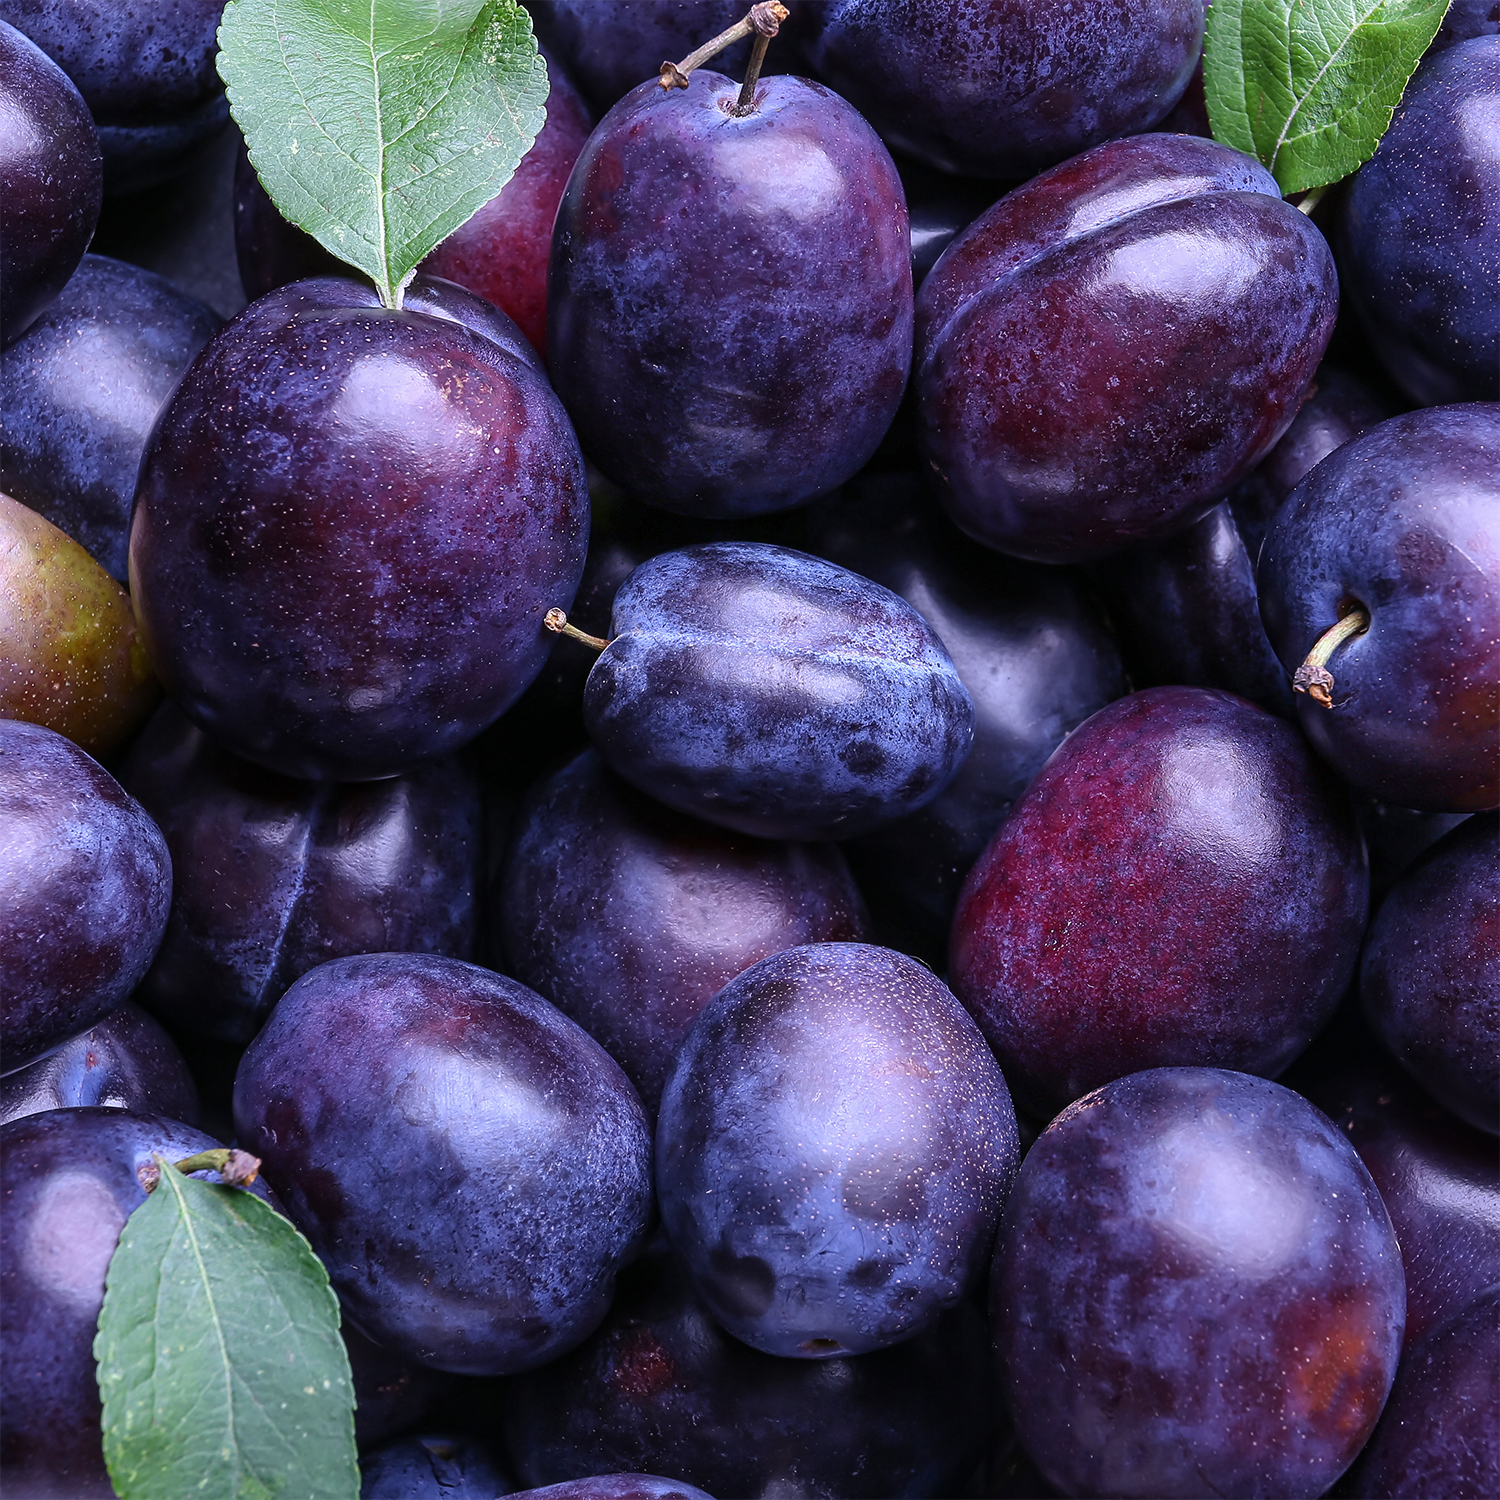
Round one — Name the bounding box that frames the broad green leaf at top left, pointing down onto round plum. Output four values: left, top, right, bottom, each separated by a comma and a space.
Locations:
219, 0, 548, 308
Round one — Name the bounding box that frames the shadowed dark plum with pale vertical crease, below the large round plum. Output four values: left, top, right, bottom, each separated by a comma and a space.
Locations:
120, 705, 482, 1044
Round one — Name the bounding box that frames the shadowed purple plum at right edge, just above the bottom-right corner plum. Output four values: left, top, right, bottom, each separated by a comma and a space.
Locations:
1289, 1046, 1500, 1349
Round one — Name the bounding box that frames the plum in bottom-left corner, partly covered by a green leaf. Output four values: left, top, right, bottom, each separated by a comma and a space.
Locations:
0, 1109, 264, 1500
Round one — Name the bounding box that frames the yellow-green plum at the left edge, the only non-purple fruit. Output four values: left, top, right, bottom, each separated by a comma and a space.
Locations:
0, 495, 161, 759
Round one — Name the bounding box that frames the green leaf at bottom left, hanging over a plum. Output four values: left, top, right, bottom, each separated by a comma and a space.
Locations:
95, 1158, 360, 1500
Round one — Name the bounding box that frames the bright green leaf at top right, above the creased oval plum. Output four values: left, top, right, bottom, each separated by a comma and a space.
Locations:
1203, 0, 1448, 194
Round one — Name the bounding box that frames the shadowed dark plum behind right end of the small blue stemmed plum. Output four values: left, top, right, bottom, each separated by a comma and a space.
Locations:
809, 474, 1128, 957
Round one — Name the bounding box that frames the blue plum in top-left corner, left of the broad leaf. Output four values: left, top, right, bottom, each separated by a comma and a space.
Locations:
0, 0, 230, 194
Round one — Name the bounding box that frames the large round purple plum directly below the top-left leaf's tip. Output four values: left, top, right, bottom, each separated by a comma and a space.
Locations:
131, 281, 588, 782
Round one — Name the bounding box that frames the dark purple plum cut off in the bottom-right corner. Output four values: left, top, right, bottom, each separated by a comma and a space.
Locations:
1350, 1287, 1500, 1500
